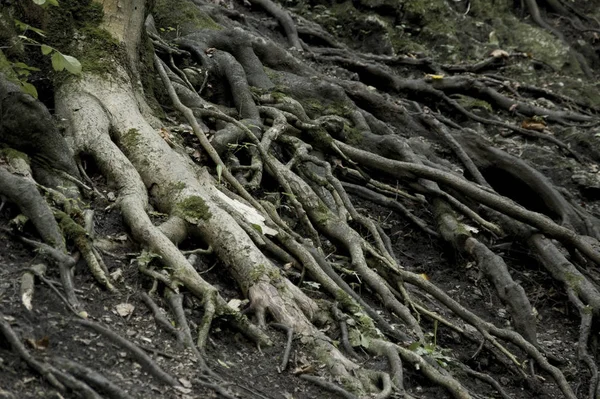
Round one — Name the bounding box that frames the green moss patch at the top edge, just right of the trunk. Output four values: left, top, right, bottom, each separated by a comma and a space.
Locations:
153, 0, 223, 34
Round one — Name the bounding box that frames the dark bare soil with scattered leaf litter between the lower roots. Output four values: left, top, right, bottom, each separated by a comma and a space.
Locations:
0, 170, 585, 399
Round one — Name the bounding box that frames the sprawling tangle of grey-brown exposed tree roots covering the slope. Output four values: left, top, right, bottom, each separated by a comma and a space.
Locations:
0, 0, 600, 399
